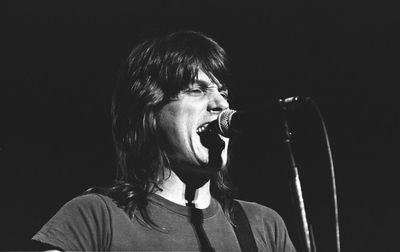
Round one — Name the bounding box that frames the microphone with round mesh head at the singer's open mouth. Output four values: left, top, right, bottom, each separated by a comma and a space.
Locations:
211, 96, 311, 138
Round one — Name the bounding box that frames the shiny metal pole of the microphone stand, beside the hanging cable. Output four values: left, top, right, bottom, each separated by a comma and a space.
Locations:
281, 102, 311, 252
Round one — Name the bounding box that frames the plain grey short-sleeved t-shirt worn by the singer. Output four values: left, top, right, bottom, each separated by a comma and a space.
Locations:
32, 194, 295, 251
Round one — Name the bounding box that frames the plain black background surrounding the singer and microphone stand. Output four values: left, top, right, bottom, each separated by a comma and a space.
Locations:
0, 0, 400, 251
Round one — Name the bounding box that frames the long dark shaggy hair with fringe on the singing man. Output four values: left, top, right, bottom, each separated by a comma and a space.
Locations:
89, 31, 232, 226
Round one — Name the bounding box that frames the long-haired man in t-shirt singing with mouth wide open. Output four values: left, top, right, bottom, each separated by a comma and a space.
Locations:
32, 31, 295, 251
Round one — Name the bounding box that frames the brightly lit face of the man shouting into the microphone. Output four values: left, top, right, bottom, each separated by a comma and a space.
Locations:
158, 70, 229, 173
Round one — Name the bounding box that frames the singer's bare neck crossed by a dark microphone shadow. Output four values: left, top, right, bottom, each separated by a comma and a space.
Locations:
156, 171, 211, 209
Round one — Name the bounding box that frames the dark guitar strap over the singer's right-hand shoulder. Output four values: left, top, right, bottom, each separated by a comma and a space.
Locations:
233, 200, 257, 252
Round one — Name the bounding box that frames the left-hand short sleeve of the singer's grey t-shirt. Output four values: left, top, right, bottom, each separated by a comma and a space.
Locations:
32, 194, 111, 251
